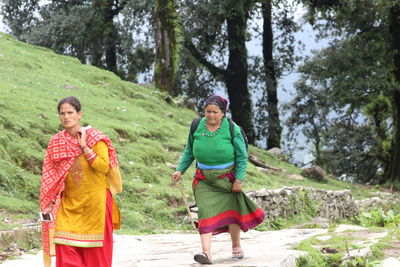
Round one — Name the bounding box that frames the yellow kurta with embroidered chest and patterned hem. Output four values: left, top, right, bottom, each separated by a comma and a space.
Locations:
54, 141, 119, 247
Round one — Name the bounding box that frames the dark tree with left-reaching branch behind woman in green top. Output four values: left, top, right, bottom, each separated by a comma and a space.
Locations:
184, 0, 255, 144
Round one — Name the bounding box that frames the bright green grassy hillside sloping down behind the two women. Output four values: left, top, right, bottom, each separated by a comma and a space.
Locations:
0, 33, 376, 233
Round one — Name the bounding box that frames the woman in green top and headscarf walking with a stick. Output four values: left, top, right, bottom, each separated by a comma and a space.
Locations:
172, 95, 265, 264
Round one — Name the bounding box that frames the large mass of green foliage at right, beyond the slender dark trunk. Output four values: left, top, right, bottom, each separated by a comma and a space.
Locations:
286, 0, 399, 182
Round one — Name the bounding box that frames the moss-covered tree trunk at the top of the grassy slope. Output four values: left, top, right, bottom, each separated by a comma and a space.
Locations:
154, 0, 178, 95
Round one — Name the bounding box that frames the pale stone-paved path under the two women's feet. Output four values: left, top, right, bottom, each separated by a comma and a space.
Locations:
0, 229, 328, 267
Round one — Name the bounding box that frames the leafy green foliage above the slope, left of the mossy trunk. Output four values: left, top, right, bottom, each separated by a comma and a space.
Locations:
1, 0, 154, 81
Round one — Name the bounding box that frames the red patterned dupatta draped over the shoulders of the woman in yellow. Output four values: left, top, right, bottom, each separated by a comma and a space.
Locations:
40, 128, 122, 266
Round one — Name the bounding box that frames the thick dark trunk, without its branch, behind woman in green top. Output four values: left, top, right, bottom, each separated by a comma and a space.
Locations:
224, 0, 255, 144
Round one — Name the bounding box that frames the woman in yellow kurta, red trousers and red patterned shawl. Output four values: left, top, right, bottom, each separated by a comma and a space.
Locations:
40, 97, 122, 267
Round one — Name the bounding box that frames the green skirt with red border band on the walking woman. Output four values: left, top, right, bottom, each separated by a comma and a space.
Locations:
193, 167, 265, 235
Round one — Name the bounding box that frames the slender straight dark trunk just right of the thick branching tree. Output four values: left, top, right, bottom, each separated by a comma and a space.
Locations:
262, 0, 282, 149
